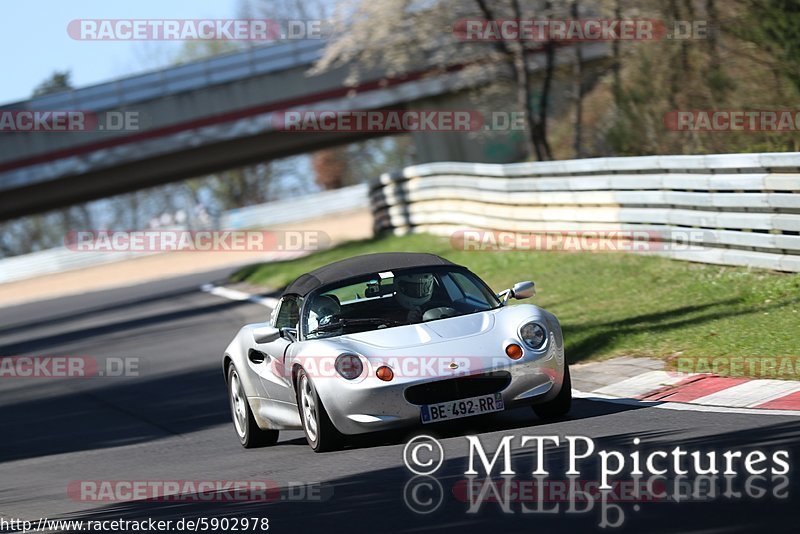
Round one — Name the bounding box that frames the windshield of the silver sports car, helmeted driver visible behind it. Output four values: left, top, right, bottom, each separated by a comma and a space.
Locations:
302, 267, 500, 339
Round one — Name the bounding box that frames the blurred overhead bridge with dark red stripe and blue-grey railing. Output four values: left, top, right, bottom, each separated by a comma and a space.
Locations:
0, 40, 608, 220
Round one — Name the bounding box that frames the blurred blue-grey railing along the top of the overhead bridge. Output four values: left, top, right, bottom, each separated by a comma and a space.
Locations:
0, 39, 327, 111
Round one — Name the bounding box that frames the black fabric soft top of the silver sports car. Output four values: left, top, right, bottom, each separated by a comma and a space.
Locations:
283, 252, 454, 296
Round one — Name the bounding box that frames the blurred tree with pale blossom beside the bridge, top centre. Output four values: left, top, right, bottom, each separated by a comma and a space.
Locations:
311, 0, 567, 160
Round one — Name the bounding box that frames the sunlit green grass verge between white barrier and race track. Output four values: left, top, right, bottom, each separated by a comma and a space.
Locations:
234, 235, 800, 370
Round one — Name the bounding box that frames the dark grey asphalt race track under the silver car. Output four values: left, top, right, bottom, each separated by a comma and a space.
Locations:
0, 271, 800, 533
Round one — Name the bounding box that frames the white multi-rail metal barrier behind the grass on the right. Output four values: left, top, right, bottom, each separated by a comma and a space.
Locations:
370, 152, 800, 272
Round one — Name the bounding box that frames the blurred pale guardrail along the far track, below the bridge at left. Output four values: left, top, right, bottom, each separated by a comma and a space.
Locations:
0, 184, 369, 284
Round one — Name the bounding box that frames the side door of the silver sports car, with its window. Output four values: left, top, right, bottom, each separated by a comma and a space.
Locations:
250, 295, 301, 403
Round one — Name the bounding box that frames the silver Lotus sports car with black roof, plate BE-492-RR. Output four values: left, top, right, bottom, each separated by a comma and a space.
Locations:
223, 252, 572, 452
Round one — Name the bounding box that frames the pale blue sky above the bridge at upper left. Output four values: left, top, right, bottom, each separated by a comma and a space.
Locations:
0, 0, 240, 105
